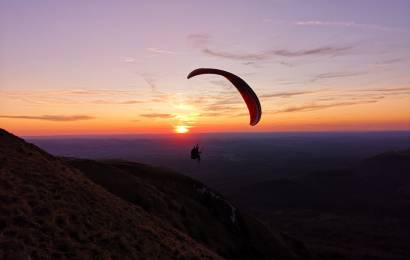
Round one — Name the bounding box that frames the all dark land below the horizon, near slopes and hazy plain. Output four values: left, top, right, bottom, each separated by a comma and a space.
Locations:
0, 128, 410, 260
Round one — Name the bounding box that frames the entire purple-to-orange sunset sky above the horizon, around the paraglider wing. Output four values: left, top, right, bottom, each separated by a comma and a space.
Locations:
0, 0, 410, 135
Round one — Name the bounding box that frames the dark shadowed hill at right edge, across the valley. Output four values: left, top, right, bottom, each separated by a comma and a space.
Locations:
230, 147, 410, 260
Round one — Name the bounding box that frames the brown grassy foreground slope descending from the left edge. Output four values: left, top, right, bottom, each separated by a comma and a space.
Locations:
0, 129, 219, 260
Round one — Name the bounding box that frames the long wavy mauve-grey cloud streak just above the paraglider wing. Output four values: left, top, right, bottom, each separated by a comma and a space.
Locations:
202, 46, 353, 60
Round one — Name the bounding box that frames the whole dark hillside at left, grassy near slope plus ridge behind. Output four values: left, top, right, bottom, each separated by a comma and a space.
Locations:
0, 129, 309, 259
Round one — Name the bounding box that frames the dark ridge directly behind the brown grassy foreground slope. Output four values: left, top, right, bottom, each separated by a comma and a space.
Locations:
66, 158, 309, 259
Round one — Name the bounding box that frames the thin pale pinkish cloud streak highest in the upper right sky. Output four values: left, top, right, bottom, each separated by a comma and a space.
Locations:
293, 20, 405, 32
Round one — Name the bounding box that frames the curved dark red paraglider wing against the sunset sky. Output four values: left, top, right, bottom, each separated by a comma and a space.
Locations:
188, 68, 262, 126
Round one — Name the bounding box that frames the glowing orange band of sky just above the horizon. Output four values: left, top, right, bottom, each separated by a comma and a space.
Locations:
0, 91, 410, 135
